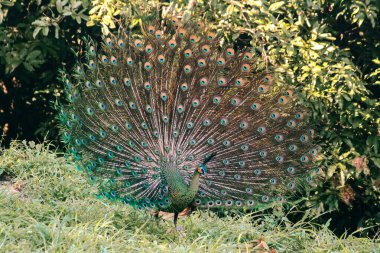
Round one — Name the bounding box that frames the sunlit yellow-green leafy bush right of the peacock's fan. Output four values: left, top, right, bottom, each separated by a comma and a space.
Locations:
185, 0, 380, 235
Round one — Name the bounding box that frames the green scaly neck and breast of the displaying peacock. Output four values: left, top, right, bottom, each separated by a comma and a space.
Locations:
162, 163, 200, 212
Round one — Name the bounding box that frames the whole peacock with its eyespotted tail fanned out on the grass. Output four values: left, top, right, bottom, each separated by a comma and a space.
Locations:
59, 17, 319, 224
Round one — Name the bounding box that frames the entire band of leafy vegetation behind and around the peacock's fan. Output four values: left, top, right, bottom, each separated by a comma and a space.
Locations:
0, 0, 380, 235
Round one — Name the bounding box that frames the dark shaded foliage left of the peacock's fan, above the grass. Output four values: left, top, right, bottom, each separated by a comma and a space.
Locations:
0, 0, 96, 145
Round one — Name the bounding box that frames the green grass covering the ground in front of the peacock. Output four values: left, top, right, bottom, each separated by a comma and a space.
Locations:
0, 142, 380, 252
